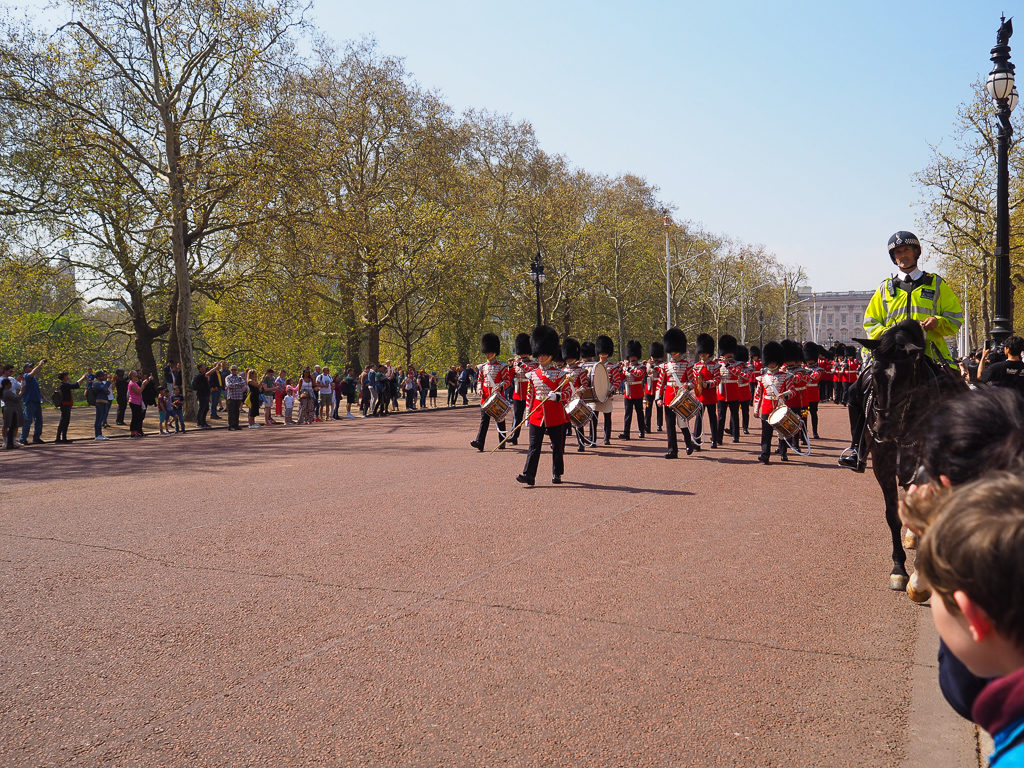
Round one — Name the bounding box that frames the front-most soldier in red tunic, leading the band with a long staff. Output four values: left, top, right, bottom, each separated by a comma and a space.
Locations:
515, 326, 570, 485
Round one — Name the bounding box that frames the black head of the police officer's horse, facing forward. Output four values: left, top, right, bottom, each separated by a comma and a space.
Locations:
854, 321, 925, 442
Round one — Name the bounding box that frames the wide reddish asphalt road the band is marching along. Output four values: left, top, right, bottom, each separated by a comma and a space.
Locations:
0, 406, 937, 766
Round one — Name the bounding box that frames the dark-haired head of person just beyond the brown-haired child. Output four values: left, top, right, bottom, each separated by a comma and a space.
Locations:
919, 387, 1024, 485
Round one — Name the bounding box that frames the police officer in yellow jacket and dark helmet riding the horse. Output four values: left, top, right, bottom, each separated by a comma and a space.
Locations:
839, 229, 964, 472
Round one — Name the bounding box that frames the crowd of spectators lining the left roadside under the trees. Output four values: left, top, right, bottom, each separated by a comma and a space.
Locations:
0, 359, 476, 449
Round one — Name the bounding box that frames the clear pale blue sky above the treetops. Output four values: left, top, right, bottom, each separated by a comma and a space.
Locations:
312, 0, 1007, 291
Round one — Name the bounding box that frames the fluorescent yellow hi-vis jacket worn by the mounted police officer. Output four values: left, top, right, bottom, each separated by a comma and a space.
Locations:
864, 272, 964, 366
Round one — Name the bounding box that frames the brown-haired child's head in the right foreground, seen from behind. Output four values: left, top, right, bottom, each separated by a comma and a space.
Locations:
916, 473, 1024, 677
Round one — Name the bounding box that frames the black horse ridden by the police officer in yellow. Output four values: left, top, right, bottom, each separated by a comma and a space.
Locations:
854, 321, 967, 591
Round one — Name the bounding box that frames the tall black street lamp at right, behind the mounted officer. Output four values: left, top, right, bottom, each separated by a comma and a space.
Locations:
985, 16, 1017, 344
